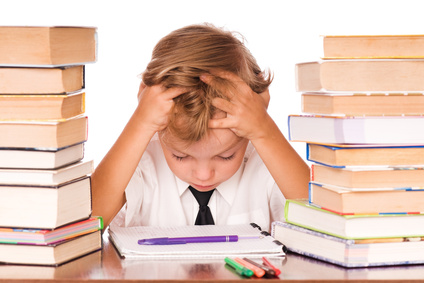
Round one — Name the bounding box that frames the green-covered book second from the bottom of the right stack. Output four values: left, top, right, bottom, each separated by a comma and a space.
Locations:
284, 199, 424, 239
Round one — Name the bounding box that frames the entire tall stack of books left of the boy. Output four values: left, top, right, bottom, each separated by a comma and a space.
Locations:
0, 26, 103, 265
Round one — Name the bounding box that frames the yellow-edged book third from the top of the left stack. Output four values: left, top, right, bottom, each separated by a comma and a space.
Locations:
0, 92, 85, 120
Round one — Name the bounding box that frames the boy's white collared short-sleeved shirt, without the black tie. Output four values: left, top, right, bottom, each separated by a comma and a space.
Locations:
113, 138, 285, 231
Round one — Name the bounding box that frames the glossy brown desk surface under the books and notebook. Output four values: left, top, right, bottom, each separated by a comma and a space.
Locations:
0, 235, 424, 282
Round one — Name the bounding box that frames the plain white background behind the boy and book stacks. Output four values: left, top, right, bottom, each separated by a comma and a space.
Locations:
0, 0, 424, 168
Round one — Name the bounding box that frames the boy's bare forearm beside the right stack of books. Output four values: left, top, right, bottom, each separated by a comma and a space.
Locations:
251, 119, 310, 198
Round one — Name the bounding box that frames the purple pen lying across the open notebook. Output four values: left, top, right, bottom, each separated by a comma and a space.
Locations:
138, 235, 238, 245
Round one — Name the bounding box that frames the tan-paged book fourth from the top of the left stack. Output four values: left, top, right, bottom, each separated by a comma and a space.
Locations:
0, 116, 87, 149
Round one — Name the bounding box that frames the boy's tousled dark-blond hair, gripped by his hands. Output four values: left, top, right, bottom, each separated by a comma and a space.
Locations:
142, 24, 272, 143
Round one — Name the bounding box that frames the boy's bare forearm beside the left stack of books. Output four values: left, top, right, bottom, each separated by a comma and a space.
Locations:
91, 110, 154, 227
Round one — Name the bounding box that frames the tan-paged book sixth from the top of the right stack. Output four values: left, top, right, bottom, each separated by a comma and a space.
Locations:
311, 164, 424, 189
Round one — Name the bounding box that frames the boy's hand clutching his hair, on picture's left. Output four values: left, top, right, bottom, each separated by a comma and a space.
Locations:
135, 82, 185, 133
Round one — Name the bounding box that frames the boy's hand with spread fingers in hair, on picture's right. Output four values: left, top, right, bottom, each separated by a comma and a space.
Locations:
200, 71, 271, 141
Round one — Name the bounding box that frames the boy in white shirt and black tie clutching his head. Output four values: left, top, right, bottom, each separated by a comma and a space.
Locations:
92, 22, 309, 229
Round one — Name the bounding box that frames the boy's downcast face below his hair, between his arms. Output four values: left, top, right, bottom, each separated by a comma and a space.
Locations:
160, 129, 248, 191
